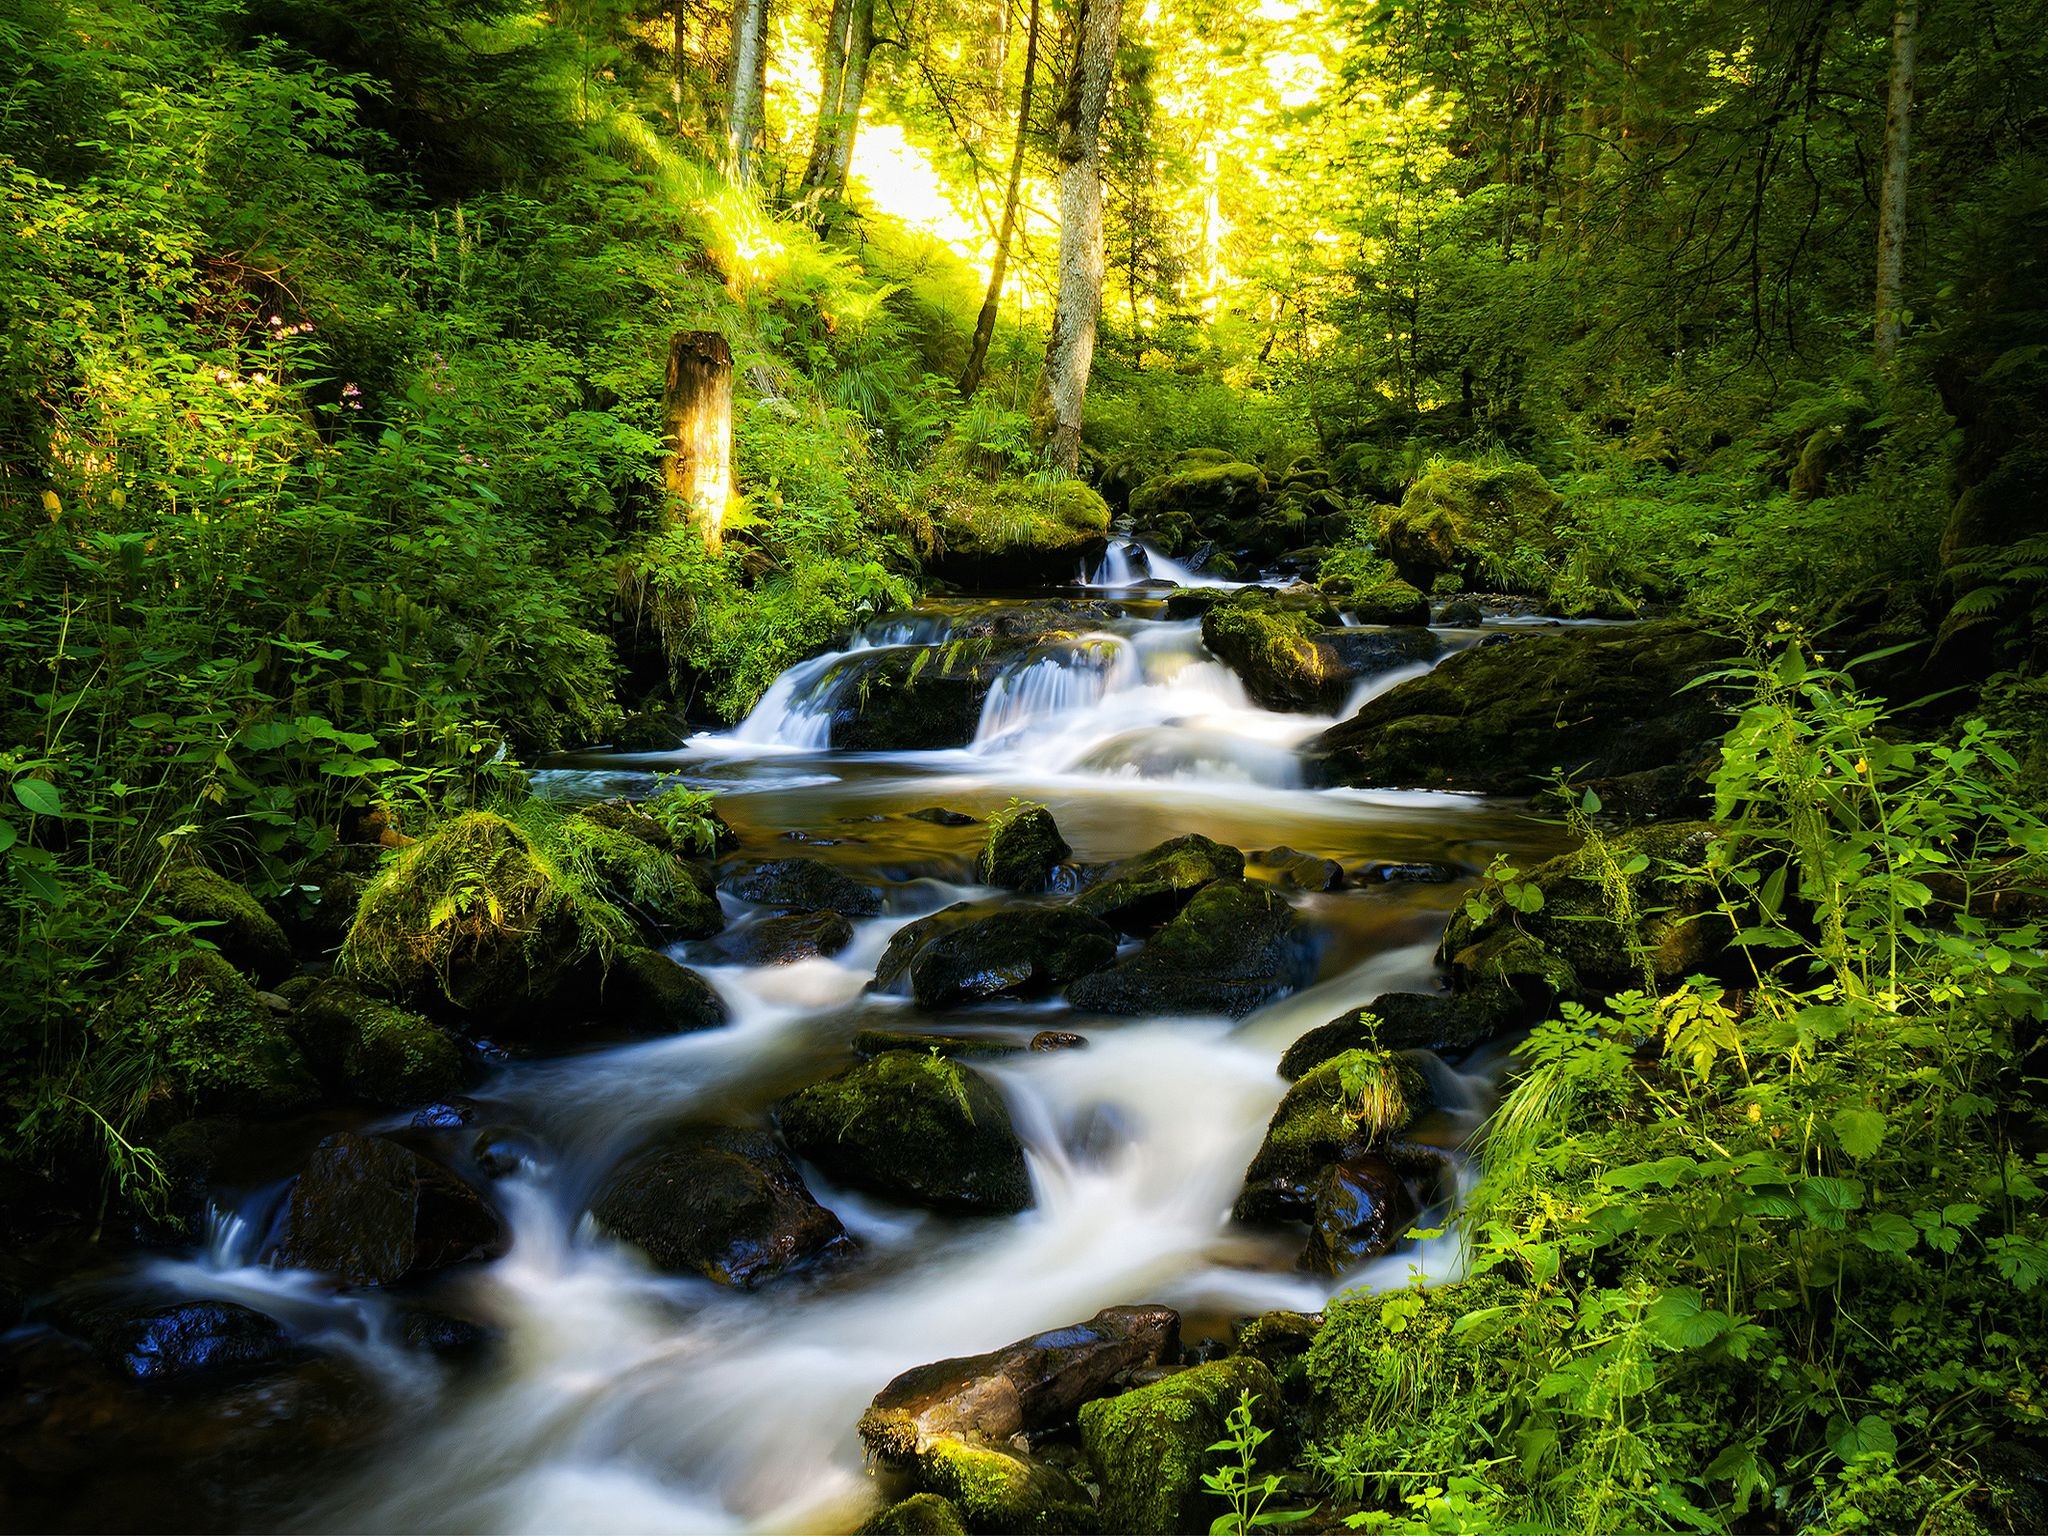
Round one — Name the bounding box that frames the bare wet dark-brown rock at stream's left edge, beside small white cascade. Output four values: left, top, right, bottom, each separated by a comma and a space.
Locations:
276, 1130, 508, 1286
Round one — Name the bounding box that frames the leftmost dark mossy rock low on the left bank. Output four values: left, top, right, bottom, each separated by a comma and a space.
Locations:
111, 950, 319, 1122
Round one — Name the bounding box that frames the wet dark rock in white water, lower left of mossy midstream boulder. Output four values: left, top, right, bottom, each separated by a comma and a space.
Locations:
592, 1126, 852, 1288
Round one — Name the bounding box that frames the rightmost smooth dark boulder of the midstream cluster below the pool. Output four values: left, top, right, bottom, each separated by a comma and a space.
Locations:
1067, 881, 1315, 1018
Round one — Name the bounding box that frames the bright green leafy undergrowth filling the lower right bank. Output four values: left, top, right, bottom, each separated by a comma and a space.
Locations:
1319, 643, 2048, 1532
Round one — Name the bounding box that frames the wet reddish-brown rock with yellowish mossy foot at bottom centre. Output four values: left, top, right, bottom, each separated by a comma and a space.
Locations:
860, 1307, 1180, 1532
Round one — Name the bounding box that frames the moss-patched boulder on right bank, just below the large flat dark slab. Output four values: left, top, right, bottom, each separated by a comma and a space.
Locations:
1438, 821, 1735, 999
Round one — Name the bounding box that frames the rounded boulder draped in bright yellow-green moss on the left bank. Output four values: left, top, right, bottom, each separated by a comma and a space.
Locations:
340, 811, 592, 1024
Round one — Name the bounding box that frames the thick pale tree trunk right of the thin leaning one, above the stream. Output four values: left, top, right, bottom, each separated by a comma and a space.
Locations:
1032, 0, 1124, 475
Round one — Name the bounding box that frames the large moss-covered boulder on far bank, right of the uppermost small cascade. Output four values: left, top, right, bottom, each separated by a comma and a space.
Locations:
1378, 463, 1563, 596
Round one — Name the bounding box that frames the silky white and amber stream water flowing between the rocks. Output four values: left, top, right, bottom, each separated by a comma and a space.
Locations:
24, 573, 1554, 1532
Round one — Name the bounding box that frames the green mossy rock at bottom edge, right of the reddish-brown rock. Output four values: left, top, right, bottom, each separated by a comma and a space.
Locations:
1081, 1356, 1280, 1536
